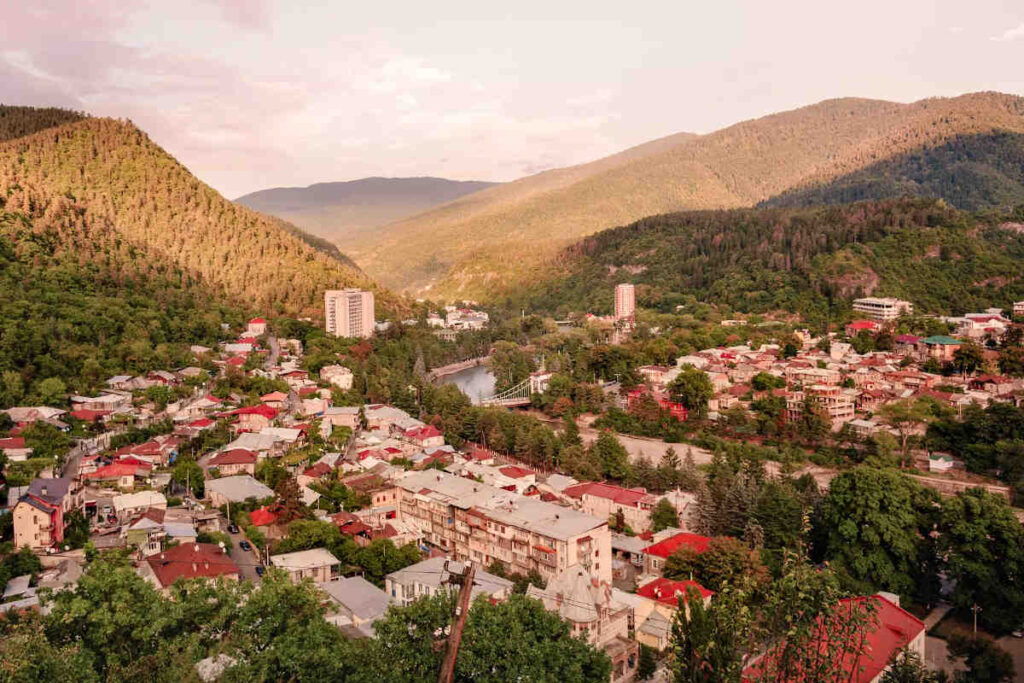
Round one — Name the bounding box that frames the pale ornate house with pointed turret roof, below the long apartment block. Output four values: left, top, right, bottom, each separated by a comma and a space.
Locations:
526, 565, 639, 681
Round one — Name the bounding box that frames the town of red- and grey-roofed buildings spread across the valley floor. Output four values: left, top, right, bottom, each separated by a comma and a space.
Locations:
6, 284, 1024, 682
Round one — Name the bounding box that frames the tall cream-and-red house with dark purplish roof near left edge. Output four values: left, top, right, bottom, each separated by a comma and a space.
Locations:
12, 478, 81, 550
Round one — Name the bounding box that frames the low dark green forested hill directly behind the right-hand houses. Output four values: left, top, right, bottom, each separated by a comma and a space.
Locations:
508, 199, 1024, 321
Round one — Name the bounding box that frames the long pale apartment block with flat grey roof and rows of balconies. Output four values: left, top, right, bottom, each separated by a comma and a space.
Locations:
395, 470, 611, 582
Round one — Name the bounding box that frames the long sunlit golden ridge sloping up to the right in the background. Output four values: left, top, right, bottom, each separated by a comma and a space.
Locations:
353, 93, 1024, 297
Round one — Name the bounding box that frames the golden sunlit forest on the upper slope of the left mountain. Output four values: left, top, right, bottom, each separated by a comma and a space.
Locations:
0, 109, 397, 314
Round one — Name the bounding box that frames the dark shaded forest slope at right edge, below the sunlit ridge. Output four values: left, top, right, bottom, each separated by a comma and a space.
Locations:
760, 131, 1024, 211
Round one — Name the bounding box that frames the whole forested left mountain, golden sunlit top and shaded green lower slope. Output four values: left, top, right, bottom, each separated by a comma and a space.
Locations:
0, 110, 400, 403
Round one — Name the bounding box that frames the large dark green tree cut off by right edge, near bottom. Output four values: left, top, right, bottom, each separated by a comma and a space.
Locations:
939, 488, 1024, 634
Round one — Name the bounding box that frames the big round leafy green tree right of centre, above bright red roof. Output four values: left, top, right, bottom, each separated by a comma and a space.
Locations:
814, 467, 939, 595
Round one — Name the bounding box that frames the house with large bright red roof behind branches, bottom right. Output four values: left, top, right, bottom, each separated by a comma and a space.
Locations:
743, 593, 926, 683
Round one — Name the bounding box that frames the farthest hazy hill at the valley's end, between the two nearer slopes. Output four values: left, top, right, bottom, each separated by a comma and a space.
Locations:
234, 177, 495, 249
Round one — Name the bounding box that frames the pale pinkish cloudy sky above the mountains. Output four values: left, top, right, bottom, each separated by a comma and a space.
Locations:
0, 0, 1024, 199
